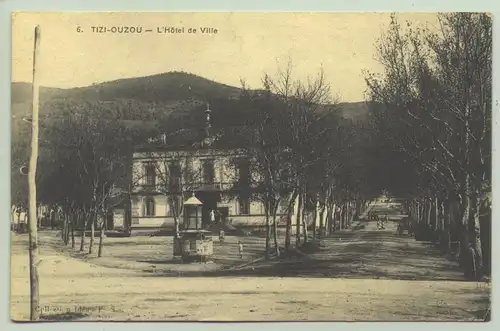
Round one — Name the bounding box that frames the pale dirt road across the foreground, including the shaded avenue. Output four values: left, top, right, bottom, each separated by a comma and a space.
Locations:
11, 202, 489, 321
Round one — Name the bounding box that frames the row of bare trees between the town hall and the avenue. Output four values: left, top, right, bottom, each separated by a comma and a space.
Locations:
224, 62, 377, 257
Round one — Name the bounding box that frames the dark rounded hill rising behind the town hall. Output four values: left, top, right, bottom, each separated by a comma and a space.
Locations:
11, 72, 368, 120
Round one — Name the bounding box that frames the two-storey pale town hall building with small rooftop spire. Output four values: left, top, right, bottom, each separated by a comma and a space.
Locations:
114, 104, 284, 231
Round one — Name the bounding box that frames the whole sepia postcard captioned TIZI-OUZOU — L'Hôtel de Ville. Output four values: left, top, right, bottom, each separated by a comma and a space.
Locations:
10, 12, 492, 321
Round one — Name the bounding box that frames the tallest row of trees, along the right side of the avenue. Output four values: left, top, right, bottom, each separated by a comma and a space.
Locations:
366, 13, 492, 277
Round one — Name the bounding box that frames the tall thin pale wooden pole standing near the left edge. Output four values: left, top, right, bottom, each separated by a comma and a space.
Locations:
28, 25, 40, 321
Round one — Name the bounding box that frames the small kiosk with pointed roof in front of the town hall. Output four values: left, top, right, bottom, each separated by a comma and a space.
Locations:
174, 195, 213, 262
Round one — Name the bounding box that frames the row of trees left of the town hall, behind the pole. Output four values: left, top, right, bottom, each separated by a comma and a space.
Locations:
12, 101, 158, 256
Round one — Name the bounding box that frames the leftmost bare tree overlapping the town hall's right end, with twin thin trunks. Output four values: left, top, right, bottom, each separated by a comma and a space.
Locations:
233, 89, 291, 258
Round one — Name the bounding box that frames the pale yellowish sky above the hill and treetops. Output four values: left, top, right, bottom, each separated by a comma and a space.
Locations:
12, 12, 436, 102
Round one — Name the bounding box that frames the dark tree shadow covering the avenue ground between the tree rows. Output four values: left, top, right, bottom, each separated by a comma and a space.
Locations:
141, 222, 472, 281
